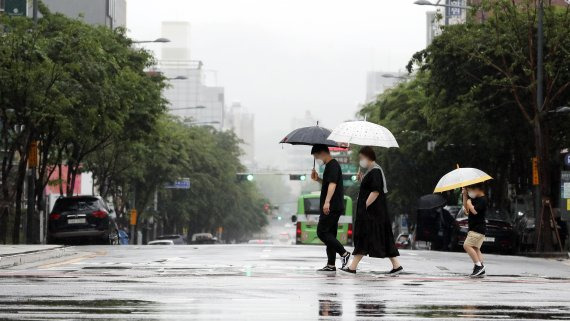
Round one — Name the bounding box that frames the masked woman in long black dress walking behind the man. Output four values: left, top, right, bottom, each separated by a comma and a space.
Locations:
343, 147, 403, 275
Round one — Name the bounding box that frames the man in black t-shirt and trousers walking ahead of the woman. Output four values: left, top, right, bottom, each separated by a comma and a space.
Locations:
311, 145, 350, 272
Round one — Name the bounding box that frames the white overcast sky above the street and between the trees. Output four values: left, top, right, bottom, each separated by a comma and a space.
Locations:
127, 0, 431, 167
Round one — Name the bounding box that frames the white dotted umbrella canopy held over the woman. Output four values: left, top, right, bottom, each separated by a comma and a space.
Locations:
328, 121, 400, 147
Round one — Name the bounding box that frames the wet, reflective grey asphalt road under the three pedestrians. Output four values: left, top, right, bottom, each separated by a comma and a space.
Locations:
0, 245, 570, 320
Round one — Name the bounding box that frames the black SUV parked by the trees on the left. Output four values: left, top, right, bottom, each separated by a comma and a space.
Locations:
47, 196, 119, 245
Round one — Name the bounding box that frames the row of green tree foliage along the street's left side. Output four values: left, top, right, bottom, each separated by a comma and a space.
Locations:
0, 6, 265, 243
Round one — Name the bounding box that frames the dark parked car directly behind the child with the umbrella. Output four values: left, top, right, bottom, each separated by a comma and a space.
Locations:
453, 208, 519, 254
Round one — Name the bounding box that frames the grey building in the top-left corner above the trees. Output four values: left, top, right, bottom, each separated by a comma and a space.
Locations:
28, 0, 127, 29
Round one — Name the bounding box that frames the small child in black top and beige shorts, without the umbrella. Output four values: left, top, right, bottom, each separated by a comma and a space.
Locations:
462, 183, 487, 277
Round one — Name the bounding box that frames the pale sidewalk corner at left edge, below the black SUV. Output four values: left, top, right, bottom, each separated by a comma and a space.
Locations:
0, 245, 73, 269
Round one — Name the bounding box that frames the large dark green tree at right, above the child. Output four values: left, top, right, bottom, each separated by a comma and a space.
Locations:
408, 0, 570, 246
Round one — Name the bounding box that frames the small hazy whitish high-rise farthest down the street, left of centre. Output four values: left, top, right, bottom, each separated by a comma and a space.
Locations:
224, 102, 255, 170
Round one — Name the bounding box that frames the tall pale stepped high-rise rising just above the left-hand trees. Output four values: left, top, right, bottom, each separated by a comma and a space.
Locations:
155, 21, 225, 129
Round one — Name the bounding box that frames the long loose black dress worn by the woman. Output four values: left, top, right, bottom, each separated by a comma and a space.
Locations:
353, 168, 400, 258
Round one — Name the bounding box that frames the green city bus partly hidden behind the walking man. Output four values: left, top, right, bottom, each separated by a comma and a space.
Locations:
295, 192, 352, 245
